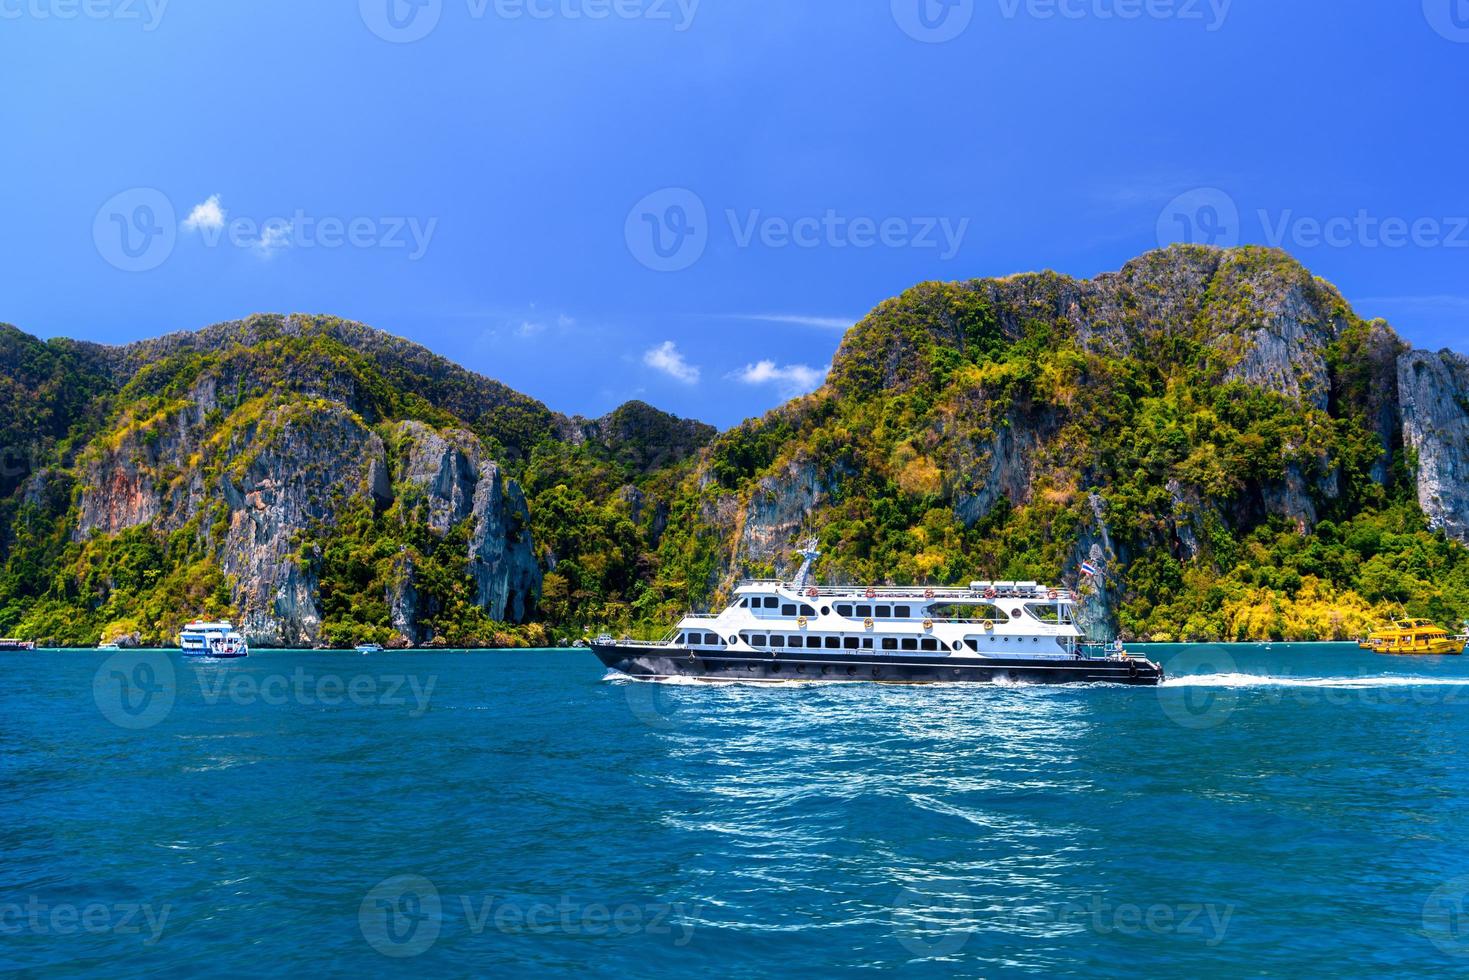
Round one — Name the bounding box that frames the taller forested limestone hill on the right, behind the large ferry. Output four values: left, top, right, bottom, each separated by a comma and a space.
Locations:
660, 247, 1469, 639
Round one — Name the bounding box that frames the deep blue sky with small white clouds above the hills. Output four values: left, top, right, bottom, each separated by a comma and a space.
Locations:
0, 0, 1469, 426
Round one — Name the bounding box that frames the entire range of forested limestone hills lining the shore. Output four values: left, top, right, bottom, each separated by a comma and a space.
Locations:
0, 247, 1469, 645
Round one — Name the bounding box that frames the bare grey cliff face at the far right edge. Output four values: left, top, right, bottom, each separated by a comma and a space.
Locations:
1397, 351, 1469, 541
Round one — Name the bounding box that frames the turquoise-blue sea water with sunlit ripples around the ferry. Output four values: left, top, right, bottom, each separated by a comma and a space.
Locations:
0, 645, 1469, 979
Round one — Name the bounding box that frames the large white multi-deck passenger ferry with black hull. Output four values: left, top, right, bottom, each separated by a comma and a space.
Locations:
592, 542, 1163, 685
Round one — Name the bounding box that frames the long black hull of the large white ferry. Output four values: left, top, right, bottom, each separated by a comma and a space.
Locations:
592, 644, 1163, 688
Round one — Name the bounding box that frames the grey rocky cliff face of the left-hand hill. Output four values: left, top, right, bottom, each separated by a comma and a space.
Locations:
42, 317, 541, 646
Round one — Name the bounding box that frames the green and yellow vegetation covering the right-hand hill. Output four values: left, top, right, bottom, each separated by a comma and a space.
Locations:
637, 250, 1469, 639
